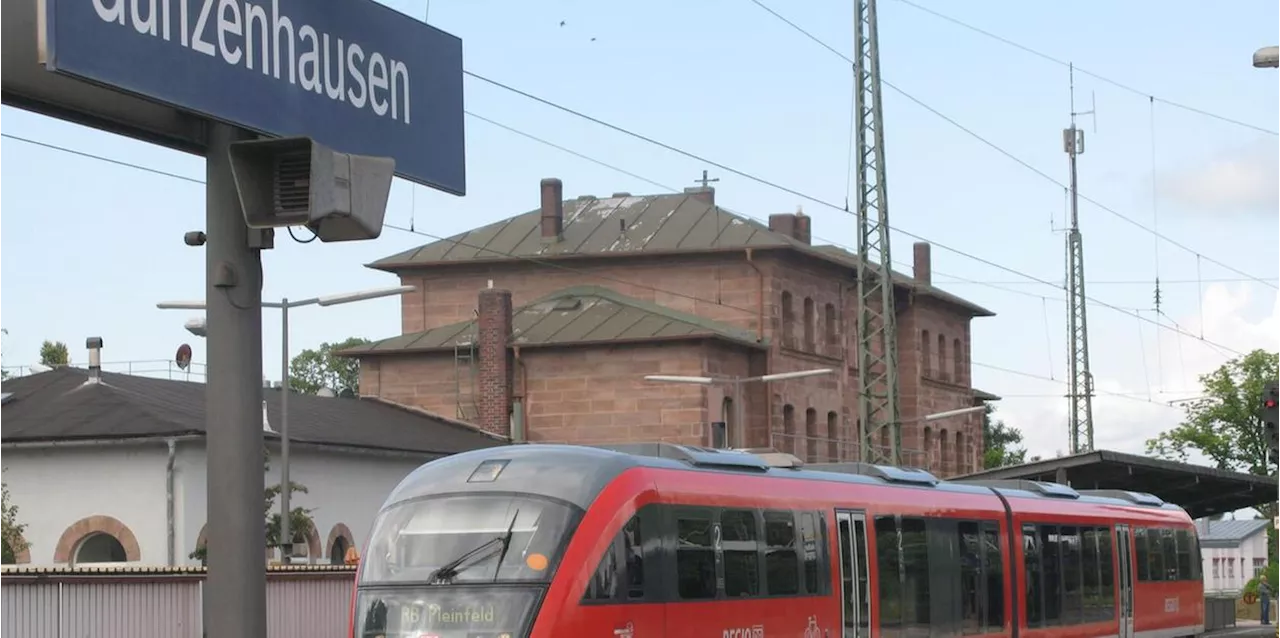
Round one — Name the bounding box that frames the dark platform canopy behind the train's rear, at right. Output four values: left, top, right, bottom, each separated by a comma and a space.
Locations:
957, 450, 1280, 519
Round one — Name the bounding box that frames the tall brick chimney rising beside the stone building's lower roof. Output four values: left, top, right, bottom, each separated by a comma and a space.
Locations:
476, 284, 512, 437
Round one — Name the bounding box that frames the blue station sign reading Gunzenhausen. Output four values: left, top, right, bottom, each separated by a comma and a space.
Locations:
38, 0, 466, 195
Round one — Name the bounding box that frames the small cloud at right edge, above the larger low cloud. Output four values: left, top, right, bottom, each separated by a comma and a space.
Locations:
1158, 146, 1280, 213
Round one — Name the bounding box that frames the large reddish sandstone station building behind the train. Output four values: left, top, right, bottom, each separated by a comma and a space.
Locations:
346, 179, 993, 475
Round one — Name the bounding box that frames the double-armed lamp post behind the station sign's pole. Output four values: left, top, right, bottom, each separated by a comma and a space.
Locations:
156, 286, 416, 562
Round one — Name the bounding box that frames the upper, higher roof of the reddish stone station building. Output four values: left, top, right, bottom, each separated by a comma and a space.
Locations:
369, 193, 995, 316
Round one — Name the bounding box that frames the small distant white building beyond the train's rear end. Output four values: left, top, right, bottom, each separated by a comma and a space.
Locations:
1196, 519, 1267, 593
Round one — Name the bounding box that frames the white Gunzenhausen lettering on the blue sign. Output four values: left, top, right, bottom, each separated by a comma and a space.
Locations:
90, 0, 412, 124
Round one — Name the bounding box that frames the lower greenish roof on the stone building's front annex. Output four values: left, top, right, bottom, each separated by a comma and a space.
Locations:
340, 286, 763, 355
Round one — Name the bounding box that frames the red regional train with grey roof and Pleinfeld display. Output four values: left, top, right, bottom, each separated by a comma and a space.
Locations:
351, 443, 1204, 638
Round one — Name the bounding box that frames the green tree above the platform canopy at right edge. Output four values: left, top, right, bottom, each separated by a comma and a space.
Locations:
1147, 350, 1280, 476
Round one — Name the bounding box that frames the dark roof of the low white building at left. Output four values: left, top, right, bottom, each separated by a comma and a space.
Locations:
0, 368, 503, 455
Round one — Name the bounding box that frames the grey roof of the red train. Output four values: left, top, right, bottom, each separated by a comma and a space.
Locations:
384, 443, 1183, 511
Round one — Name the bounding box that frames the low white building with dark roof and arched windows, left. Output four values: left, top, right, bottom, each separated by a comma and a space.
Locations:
0, 368, 504, 566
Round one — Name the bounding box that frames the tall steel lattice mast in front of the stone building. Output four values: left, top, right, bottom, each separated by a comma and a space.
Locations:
854, 0, 902, 465
